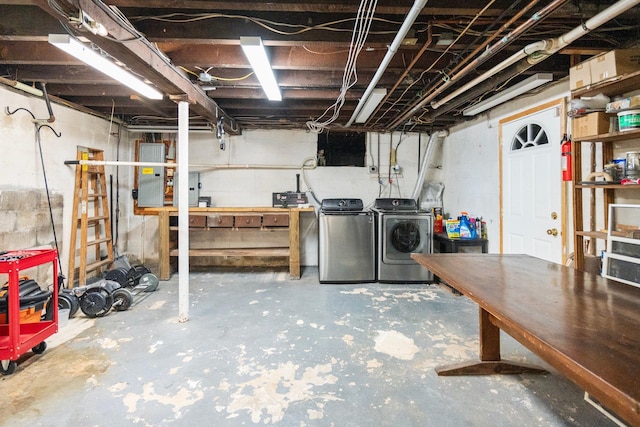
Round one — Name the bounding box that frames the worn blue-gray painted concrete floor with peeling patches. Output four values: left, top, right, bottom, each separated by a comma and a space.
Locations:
0, 268, 614, 427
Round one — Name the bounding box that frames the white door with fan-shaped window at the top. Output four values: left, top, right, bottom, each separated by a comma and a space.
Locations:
501, 104, 563, 263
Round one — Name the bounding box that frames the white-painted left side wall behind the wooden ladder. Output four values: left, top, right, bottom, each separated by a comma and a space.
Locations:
0, 86, 136, 280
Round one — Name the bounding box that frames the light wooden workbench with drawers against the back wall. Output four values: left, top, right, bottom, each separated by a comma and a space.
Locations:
158, 207, 313, 280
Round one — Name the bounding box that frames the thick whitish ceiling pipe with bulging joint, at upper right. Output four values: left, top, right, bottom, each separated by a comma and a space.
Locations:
431, 0, 640, 109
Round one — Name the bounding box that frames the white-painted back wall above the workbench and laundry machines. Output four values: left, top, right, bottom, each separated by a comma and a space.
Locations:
150, 130, 438, 265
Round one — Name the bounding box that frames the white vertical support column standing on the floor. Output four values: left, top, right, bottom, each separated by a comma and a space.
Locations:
177, 101, 189, 322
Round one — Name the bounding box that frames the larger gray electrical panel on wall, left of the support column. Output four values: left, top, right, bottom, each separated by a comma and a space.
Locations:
138, 143, 165, 208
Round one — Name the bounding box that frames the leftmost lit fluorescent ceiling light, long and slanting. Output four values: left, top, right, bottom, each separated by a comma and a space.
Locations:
49, 34, 162, 99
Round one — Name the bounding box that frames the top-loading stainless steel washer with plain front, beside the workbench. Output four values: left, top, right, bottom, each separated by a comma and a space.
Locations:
318, 199, 376, 283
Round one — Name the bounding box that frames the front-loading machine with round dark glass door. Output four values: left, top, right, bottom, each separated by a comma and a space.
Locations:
373, 199, 434, 283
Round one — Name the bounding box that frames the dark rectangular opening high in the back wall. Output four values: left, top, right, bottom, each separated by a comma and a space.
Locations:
318, 132, 367, 167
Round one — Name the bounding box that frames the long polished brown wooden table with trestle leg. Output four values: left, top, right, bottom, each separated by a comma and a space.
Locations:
412, 254, 640, 426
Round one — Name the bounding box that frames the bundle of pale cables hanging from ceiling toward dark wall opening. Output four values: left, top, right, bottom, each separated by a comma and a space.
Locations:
307, 0, 378, 133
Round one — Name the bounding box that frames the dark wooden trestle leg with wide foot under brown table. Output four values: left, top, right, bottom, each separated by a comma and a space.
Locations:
435, 307, 547, 376
